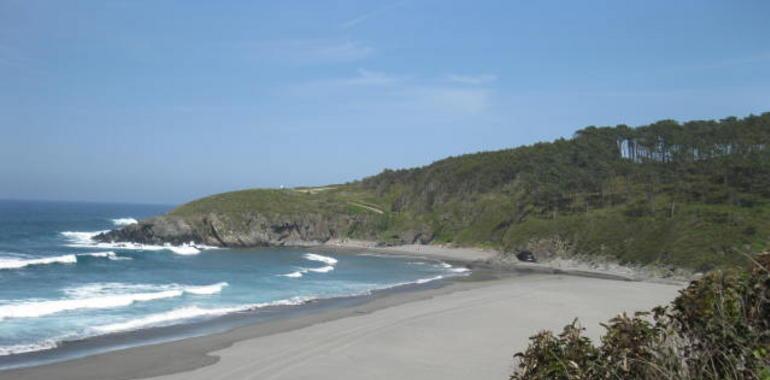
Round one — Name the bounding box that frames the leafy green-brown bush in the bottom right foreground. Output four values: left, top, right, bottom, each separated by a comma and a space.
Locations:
511, 255, 770, 380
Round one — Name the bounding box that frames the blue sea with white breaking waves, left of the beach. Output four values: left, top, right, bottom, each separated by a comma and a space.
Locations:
0, 200, 464, 363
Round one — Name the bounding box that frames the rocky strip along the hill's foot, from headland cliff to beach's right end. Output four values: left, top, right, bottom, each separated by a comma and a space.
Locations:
99, 214, 697, 283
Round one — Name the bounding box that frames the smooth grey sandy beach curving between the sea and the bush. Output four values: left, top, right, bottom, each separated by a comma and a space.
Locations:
0, 247, 681, 380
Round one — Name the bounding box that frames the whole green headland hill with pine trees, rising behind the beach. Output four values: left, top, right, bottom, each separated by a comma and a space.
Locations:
100, 113, 770, 269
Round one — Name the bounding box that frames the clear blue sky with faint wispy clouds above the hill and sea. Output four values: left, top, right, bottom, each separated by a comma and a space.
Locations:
0, 0, 770, 203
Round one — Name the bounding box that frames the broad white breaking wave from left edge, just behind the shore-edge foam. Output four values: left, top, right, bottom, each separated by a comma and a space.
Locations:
0, 282, 227, 321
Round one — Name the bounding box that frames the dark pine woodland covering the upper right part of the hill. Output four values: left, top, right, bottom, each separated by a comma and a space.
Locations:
362, 113, 770, 216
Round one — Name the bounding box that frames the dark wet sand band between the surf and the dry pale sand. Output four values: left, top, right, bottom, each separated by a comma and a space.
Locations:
0, 271, 500, 380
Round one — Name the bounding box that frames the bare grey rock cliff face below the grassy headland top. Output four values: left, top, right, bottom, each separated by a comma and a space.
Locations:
95, 209, 432, 247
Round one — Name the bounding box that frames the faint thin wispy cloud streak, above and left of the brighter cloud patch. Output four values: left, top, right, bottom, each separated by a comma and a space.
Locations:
239, 39, 374, 64
